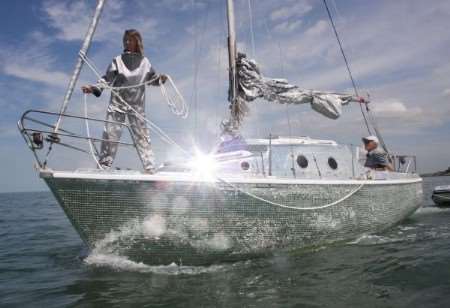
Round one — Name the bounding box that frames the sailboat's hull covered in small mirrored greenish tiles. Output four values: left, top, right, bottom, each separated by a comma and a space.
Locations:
44, 172, 422, 264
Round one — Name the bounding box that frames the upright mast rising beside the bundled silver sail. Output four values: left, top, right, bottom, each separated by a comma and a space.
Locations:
227, 0, 238, 127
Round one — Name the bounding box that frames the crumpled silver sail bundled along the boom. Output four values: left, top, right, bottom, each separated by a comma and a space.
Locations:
236, 53, 358, 119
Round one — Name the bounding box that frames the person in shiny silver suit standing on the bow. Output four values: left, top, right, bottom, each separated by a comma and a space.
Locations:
81, 29, 167, 173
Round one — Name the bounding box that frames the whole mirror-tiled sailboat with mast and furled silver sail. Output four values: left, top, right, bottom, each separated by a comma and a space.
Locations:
18, 0, 422, 264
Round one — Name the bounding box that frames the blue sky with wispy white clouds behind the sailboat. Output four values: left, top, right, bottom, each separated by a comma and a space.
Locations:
0, 0, 450, 192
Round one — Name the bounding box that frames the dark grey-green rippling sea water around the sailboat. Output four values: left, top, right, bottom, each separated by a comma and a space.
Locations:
0, 177, 450, 308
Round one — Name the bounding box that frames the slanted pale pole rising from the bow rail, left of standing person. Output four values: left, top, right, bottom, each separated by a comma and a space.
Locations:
53, 0, 106, 133
